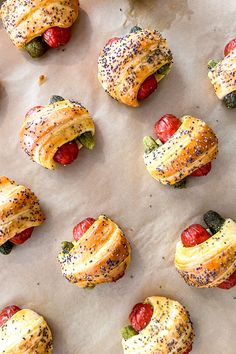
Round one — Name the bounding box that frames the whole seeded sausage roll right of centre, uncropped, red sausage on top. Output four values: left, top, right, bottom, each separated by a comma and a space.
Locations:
143, 114, 218, 188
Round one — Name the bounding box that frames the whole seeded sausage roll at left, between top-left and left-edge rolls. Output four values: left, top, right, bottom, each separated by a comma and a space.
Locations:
20, 96, 95, 170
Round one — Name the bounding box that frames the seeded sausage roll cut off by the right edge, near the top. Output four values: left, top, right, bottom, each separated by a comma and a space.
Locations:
208, 38, 236, 108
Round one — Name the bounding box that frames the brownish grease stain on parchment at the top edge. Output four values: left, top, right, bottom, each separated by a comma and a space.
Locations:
123, 0, 193, 31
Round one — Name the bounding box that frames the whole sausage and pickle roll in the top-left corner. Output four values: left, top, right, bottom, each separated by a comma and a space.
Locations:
0, 0, 79, 58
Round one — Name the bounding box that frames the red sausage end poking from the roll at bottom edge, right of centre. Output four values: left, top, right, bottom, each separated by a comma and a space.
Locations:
129, 303, 153, 332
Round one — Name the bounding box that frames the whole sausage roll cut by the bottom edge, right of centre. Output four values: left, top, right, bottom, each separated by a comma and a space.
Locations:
121, 296, 194, 354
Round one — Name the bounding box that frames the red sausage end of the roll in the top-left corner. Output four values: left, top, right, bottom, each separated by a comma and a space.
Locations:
43, 27, 71, 48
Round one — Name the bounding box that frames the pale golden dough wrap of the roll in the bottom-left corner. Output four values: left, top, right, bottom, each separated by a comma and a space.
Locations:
0, 309, 53, 354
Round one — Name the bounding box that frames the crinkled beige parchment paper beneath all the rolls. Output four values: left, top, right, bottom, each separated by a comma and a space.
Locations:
0, 0, 236, 354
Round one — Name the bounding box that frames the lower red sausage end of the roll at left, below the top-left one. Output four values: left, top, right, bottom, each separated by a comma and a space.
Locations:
53, 141, 79, 165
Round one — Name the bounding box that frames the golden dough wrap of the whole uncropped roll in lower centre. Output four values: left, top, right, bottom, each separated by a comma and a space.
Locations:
58, 215, 131, 287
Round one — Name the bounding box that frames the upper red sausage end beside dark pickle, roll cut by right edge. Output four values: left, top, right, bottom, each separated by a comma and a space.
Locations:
181, 224, 211, 247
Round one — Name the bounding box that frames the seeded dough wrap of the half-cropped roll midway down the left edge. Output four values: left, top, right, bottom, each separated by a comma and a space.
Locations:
0, 176, 45, 246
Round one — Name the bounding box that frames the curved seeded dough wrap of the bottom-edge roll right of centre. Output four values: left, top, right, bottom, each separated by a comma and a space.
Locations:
122, 296, 194, 354
